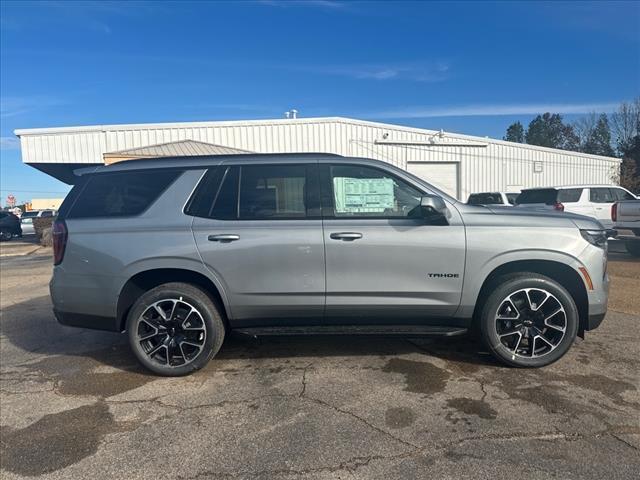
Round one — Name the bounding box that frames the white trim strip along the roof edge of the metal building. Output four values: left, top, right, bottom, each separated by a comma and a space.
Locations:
14, 117, 620, 163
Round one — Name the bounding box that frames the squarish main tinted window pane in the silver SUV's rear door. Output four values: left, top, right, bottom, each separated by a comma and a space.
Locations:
241, 165, 307, 219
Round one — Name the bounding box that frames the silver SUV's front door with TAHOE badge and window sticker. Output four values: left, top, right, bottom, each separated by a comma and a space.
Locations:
320, 163, 465, 323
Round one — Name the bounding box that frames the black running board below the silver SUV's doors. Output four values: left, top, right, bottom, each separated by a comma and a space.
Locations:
232, 325, 467, 337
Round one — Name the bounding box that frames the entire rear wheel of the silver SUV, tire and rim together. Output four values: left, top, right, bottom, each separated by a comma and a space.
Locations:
127, 283, 225, 377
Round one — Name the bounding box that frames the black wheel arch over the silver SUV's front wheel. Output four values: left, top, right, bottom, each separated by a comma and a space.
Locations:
473, 260, 589, 336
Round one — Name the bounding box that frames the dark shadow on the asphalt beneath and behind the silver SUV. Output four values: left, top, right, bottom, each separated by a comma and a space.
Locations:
0, 296, 500, 373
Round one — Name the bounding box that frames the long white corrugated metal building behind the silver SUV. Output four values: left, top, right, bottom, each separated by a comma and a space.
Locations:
15, 117, 620, 200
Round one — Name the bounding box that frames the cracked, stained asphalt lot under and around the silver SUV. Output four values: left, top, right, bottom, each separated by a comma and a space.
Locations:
0, 252, 640, 480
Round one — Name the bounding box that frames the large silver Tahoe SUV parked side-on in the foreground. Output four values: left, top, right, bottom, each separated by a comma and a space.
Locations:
50, 154, 609, 375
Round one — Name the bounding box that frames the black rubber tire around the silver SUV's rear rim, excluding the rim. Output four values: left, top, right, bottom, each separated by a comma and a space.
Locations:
127, 284, 224, 377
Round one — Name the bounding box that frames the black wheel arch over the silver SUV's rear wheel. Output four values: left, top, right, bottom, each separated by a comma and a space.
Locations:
116, 268, 229, 332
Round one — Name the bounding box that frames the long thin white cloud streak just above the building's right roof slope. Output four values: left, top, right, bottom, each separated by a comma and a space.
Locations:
358, 102, 620, 119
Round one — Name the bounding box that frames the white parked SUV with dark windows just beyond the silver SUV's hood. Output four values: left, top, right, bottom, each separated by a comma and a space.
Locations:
516, 185, 636, 228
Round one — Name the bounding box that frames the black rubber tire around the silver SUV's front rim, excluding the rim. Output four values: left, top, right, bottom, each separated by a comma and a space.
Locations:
480, 276, 579, 367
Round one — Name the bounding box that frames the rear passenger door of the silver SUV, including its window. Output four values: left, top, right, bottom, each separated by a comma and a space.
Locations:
192, 163, 325, 325
